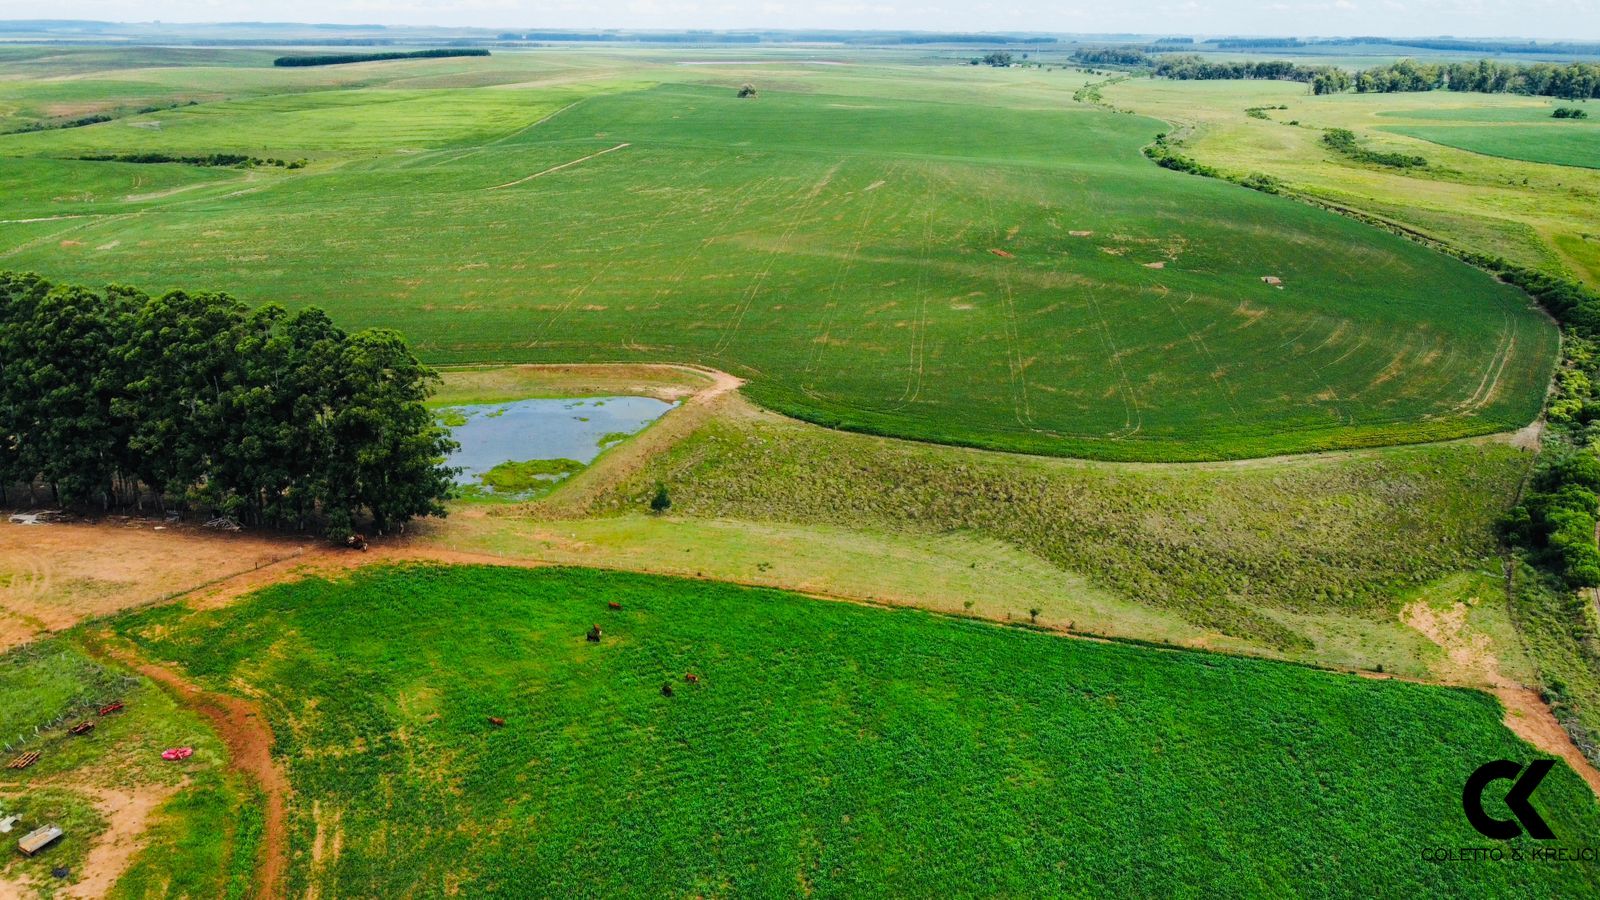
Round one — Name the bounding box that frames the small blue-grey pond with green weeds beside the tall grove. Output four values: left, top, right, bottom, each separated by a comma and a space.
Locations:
438, 397, 677, 500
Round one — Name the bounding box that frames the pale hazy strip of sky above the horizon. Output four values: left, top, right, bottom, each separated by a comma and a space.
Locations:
0, 0, 1600, 40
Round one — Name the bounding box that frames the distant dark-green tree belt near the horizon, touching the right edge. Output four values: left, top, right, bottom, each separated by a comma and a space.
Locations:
1355, 59, 1600, 99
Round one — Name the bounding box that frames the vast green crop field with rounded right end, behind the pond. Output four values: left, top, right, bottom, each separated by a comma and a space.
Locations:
0, 53, 1555, 460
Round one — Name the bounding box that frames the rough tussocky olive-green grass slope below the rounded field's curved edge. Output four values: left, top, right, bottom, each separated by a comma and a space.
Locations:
574, 395, 1530, 646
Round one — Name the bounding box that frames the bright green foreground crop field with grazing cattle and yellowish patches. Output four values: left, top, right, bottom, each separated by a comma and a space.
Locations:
118, 567, 1600, 897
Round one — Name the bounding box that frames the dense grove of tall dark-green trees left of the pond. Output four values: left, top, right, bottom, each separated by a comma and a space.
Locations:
0, 272, 454, 536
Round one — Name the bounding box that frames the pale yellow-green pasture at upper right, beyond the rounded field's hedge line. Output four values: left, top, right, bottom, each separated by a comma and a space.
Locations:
1106, 78, 1600, 287
